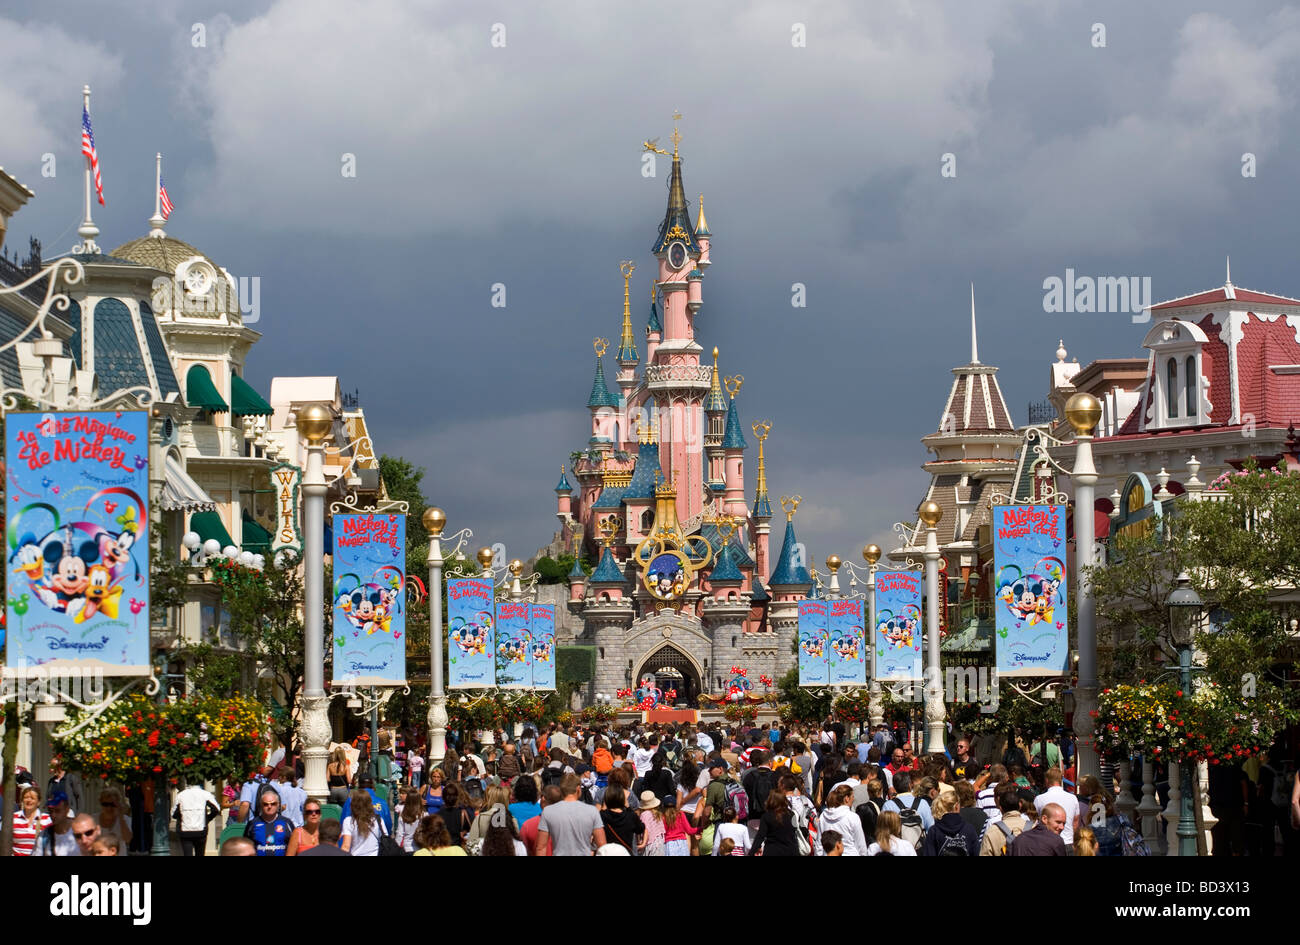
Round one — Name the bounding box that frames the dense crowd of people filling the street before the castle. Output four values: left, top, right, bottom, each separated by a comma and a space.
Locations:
13, 719, 1300, 857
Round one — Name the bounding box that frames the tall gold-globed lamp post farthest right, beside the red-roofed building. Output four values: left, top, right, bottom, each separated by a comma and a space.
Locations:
1065, 393, 1101, 779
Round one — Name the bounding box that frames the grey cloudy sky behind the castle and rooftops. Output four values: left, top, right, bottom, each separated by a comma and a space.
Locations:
0, 0, 1300, 569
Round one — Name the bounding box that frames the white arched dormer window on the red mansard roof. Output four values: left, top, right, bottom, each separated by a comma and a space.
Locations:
1143, 318, 1210, 430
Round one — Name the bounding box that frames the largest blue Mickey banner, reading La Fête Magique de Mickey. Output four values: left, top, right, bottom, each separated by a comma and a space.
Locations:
5, 411, 151, 676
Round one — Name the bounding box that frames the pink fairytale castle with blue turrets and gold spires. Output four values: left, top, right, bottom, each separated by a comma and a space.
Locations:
555, 129, 813, 707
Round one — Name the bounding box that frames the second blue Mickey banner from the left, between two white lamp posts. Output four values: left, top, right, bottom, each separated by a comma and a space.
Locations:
332, 512, 406, 686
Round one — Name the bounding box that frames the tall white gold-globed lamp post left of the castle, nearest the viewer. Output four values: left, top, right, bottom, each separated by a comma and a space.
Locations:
296, 404, 334, 799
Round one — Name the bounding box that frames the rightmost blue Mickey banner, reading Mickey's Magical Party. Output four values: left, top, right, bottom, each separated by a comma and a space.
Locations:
993, 506, 1070, 676
